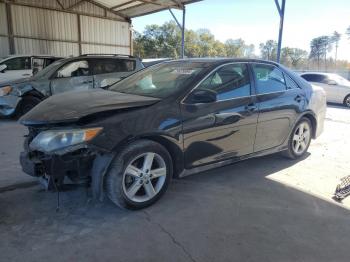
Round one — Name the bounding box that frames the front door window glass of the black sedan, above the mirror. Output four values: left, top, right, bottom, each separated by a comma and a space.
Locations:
197, 64, 250, 101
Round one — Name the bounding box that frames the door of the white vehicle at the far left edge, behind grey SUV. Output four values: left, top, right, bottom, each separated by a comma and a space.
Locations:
0, 56, 32, 81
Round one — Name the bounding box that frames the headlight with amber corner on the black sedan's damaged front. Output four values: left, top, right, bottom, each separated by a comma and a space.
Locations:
29, 127, 102, 152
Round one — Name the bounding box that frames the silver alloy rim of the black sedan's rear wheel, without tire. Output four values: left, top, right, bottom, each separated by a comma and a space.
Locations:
292, 122, 311, 155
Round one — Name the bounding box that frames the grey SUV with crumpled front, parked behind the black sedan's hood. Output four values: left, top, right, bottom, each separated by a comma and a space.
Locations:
0, 54, 143, 116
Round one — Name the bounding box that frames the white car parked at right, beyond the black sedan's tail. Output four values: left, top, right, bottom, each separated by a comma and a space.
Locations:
300, 72, 350, 108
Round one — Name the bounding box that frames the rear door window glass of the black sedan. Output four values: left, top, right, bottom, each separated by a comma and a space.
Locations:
252, 64, 287, 94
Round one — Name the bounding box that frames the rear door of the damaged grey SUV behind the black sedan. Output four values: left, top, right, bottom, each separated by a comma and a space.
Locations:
92, 58, 136, 88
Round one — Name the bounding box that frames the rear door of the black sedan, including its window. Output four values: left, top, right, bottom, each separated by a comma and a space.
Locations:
252, 63, 306, 152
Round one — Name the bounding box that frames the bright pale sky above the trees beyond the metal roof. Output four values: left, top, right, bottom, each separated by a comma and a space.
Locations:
132, 0, 350, 61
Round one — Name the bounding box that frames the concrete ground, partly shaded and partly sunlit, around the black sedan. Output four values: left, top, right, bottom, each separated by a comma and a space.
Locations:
0, 105, 350, 262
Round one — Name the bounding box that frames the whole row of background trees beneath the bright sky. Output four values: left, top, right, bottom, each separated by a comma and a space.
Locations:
133, 22, 350, 70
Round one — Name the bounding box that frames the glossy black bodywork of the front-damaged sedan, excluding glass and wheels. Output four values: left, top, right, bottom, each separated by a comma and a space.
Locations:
21, 59, 325, 199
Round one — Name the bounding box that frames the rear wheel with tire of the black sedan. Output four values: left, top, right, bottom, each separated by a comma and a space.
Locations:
283, 117, 312, 159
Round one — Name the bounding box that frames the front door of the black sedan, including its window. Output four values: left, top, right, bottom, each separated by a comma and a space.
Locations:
181, 63, 258, 168
